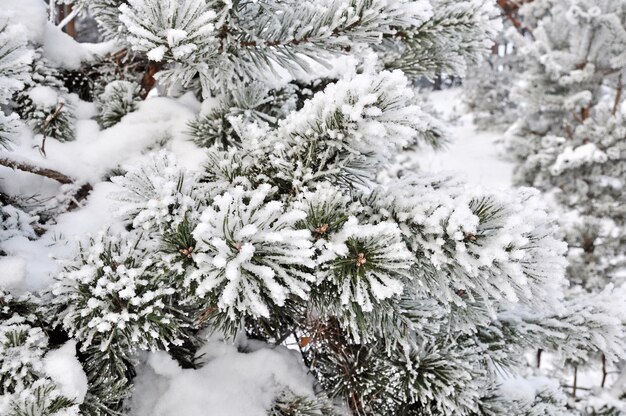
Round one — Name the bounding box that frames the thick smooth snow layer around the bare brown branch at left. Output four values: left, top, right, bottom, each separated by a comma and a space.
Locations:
0, 94, 205, 291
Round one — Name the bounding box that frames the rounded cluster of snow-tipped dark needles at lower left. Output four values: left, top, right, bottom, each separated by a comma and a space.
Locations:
51, 234, 182, 352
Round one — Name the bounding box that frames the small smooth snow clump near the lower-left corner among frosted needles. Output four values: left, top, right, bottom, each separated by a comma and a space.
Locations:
43, 341, 87, 403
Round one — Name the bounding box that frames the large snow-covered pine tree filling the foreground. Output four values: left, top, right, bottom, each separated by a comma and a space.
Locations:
0, 0, 625, 416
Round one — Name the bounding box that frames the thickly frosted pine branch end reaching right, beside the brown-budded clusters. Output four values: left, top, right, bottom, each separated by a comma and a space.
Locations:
377, 176, 565, 306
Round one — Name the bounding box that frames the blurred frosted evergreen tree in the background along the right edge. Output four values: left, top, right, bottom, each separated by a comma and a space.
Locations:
507, 0, 626, 414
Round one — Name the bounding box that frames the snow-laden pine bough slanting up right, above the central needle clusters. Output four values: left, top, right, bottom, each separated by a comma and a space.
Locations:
272, 70, 441, 187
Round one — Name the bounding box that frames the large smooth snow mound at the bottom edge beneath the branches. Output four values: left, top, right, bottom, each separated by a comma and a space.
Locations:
131, 339, 313, 416
